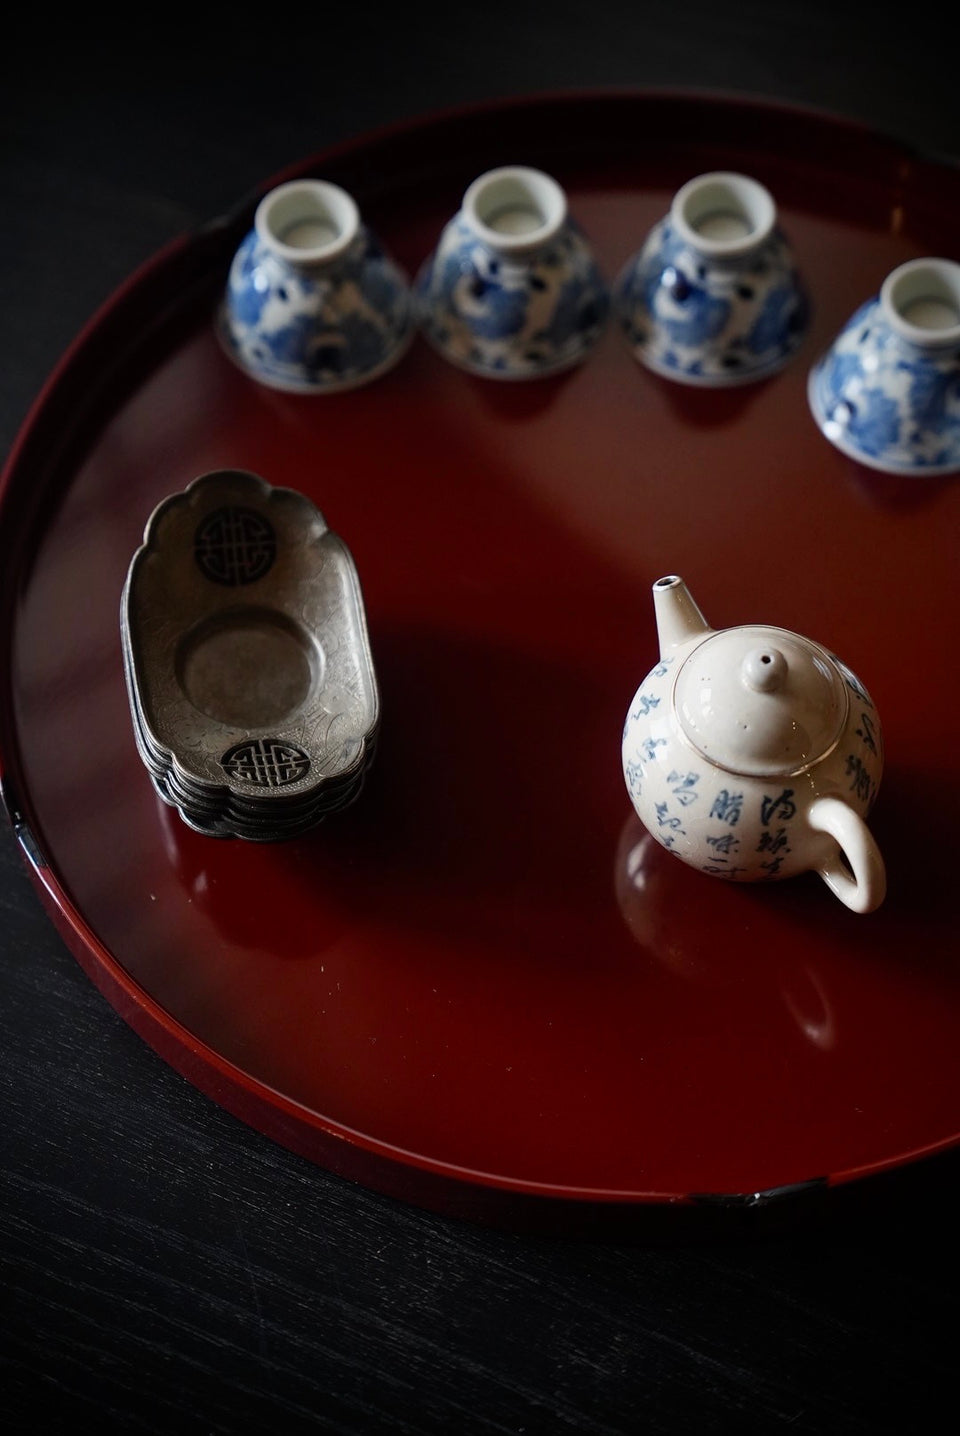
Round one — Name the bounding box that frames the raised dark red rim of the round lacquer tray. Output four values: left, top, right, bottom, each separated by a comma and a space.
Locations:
0, 86, 960, 1229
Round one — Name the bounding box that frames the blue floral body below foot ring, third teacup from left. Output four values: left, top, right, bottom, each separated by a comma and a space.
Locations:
614, 217, 809, 386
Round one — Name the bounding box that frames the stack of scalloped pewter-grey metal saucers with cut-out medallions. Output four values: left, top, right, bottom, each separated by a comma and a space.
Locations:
121, 470, 379, 841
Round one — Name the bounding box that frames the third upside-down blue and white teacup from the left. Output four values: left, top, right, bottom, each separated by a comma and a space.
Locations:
614, 171, 809, 388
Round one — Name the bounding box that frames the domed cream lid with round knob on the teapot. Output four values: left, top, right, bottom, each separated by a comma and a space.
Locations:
674, 625, 850, 777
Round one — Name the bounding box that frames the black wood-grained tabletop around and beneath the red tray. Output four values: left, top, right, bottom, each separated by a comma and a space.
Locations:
0, 0, 960, 1436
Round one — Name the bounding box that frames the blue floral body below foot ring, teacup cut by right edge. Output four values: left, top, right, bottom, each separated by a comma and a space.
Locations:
808, 297, 960, 474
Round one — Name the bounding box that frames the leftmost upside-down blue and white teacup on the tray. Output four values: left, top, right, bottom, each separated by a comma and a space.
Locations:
217, 180, 415, 393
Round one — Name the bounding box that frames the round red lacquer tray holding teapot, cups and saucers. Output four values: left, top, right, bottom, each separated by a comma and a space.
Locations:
0, 93, 960, 1218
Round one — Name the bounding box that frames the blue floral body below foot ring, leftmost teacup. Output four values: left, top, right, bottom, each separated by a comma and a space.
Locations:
218, 227, 413, 393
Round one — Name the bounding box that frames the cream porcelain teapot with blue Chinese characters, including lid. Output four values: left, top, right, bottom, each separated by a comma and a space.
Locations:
623, 574, 887, 912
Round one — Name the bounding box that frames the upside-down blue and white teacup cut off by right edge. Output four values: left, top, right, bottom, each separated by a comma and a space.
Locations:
808, 258, 960, 475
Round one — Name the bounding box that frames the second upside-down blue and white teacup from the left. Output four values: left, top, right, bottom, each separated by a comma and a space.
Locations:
415, 165, 610, 379
